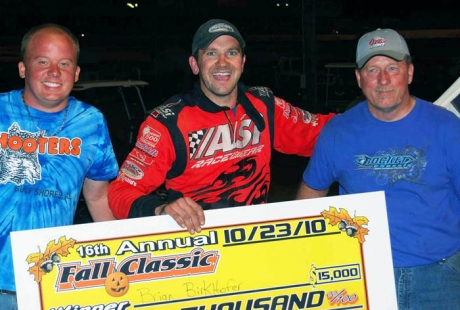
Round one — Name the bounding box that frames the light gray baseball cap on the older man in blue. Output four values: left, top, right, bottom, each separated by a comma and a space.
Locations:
356, 28, 410, 68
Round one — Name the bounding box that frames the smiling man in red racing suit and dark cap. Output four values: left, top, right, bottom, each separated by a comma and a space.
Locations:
109, 19, 334, 234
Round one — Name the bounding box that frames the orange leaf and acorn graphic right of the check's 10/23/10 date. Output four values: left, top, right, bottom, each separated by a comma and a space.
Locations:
321, 207, 369, 244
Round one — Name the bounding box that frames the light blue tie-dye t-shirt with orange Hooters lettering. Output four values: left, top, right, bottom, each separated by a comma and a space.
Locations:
0, 90, 118, 291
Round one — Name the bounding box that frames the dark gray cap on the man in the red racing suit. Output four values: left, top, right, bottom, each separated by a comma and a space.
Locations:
192, 19, 246, 55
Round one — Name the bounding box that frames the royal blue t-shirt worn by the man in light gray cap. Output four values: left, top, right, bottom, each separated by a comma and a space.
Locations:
303, 98, 460, 267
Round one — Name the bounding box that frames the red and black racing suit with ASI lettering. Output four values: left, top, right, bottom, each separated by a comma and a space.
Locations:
108, 82, 335, 219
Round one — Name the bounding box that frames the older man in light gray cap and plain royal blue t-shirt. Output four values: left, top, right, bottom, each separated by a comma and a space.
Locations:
297, 29, 460, 310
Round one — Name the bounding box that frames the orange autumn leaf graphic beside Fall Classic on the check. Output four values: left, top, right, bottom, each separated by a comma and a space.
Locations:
27, 236, 75, 282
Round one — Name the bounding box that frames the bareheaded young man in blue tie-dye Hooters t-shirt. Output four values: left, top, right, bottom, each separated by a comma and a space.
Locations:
0, 24, 118, 310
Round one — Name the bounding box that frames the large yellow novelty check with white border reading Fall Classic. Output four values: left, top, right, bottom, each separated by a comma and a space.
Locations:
11, 192, 397, 310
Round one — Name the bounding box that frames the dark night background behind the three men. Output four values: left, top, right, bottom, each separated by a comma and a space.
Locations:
0, 0, 460, 223
